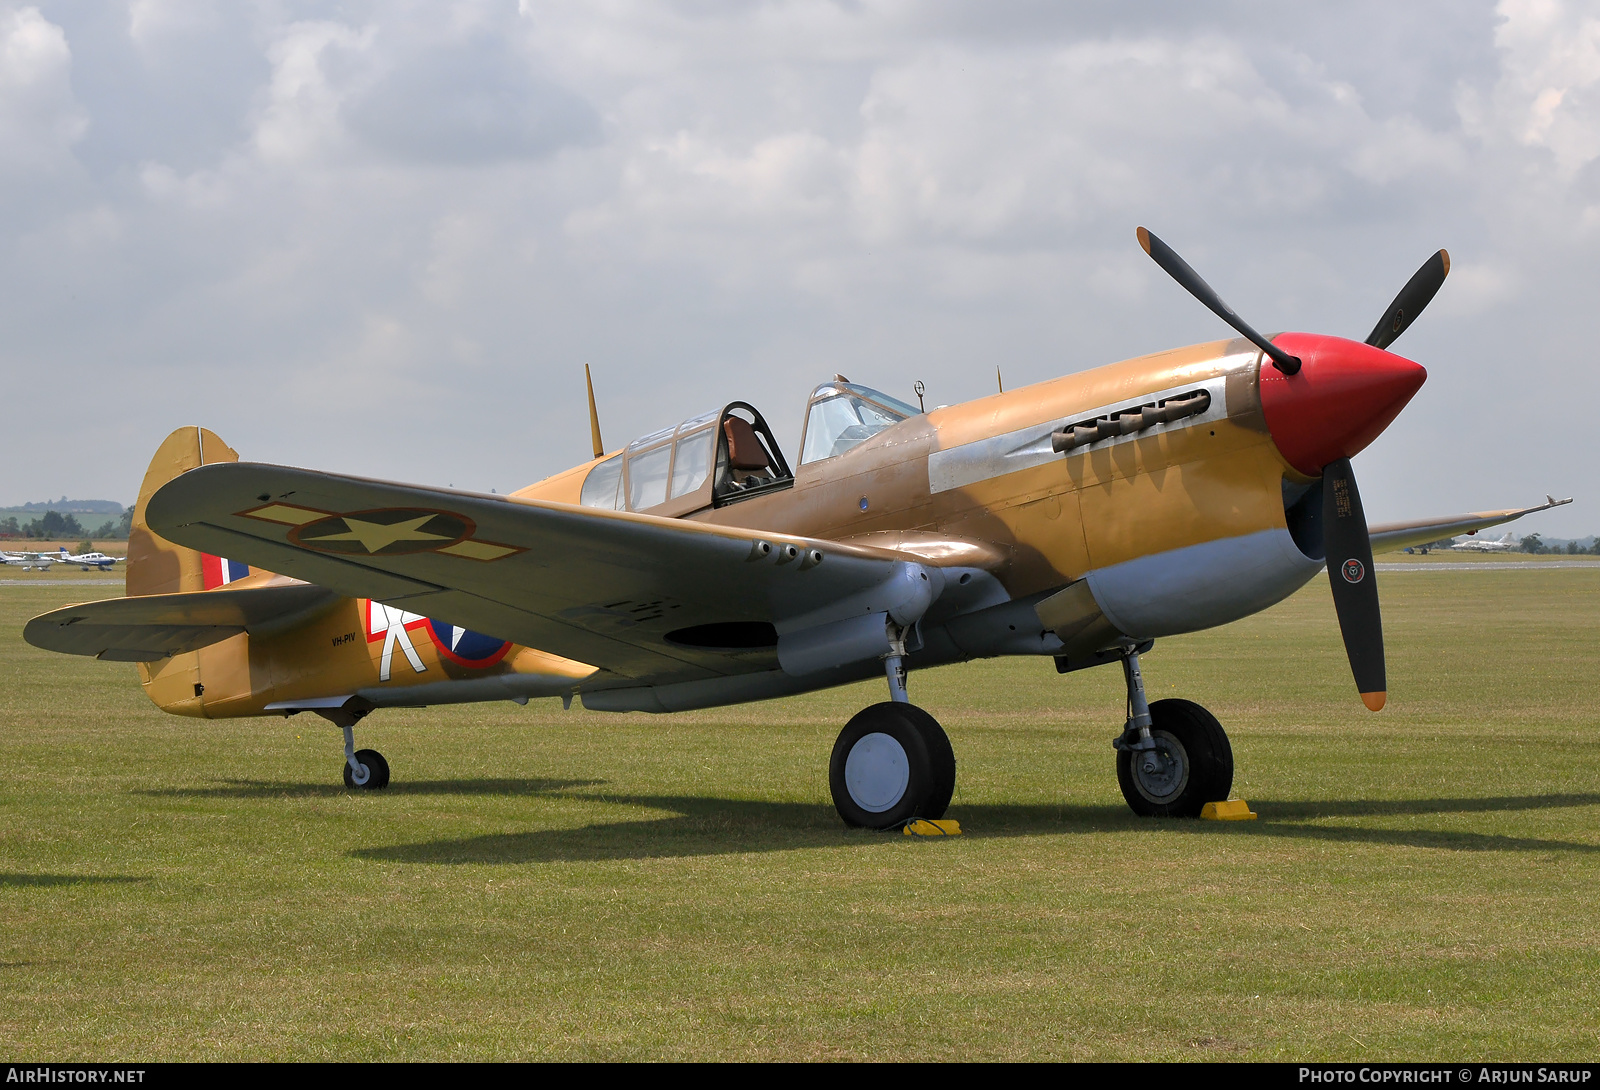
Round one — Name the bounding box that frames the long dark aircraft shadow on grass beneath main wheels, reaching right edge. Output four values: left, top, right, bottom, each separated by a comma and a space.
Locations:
350, 794, 1600, 864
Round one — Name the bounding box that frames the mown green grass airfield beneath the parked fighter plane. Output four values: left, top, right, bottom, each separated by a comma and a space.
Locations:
0, 569, 1600, 1060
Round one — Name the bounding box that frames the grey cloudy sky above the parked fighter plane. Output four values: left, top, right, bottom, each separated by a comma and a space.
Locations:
0, 0, 1600, 536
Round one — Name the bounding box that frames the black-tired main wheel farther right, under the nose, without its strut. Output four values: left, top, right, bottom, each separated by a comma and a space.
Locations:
1117, 699, 1234, 818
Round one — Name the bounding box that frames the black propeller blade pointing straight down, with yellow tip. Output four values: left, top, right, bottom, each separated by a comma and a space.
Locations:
1322, 458, 1389, 712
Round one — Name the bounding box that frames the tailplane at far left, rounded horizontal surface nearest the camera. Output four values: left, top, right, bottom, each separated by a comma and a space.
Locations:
22, 583, 339, 663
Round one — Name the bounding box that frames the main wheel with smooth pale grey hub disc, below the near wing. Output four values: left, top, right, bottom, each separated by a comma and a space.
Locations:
827, 701, 955, 829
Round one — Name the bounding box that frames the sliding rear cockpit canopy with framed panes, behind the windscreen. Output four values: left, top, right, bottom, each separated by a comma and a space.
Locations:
579, 402, 794, 515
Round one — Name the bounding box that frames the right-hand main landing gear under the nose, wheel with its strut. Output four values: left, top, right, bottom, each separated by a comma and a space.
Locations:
1112, 648, 1234, 818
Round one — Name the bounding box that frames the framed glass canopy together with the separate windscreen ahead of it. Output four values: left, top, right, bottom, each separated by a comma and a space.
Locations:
579, 375, 922, 517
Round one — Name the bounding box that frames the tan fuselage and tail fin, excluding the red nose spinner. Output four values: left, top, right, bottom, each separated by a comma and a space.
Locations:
128, 339, 1350, 717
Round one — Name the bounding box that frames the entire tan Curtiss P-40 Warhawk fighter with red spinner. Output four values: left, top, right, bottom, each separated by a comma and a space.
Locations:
26, 227, 1574, 829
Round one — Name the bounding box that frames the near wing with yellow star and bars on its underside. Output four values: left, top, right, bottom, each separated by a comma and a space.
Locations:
146, 463, 942, 683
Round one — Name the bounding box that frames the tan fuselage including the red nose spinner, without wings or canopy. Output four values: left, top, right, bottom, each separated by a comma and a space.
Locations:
130, 335, 1421, 715
